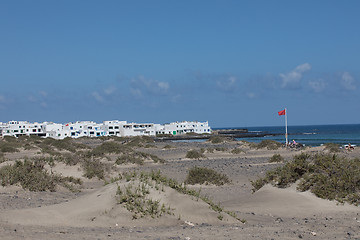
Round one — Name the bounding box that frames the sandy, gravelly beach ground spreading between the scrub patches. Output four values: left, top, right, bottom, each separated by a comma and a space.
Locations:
0, 139, 360, 239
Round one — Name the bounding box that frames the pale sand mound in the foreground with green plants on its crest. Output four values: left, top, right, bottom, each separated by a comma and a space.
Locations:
0, 182, 238, 227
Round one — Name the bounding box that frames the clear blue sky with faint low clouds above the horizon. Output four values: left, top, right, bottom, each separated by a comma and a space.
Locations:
0, 0, 360, 127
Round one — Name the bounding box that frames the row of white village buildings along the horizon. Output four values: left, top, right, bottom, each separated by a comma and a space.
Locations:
0, 120, 212, 139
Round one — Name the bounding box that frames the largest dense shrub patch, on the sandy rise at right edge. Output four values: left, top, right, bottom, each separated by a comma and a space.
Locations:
252, 153, 360, 205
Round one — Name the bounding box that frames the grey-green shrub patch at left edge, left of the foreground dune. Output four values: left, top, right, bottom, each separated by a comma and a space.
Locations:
0, 159, 81, 192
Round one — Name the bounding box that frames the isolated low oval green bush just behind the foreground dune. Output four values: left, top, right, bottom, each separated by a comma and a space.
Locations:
185, 167, 230, 186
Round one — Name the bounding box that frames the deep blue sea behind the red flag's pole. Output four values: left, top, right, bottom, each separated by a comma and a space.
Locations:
233, 124, 360, 146
